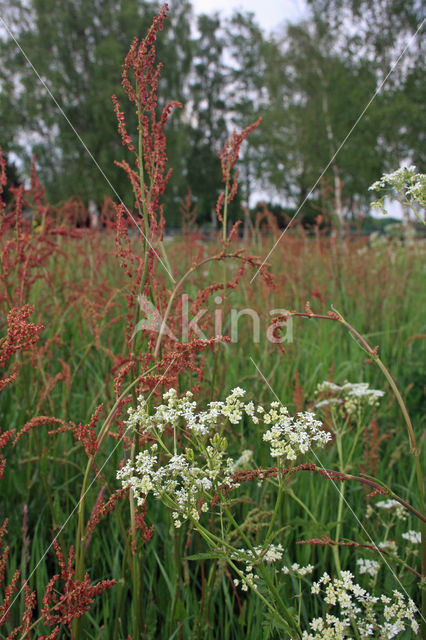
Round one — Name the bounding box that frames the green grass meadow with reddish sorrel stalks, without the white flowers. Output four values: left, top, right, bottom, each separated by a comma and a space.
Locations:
0, 5, 425, 640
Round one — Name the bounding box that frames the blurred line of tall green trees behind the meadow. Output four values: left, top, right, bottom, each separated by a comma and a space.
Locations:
0, 0, 426, 226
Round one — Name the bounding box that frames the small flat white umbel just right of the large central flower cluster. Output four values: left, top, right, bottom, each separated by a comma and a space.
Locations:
315, 381, 385, 415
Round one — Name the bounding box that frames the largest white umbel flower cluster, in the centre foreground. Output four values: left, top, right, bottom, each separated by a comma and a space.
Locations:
117, 387, 331, 527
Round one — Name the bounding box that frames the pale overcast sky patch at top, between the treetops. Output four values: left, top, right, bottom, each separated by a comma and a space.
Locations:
191, 0, 306, 31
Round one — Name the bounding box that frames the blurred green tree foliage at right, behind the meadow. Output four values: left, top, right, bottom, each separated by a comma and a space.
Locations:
262, 2, 424, 221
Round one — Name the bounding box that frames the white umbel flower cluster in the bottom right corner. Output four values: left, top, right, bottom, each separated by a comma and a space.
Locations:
302, 571, 419, 640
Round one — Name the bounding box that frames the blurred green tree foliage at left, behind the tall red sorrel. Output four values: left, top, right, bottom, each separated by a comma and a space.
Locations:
0, 0, 190, 204
